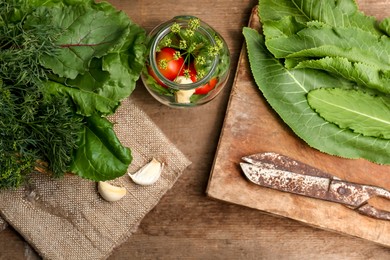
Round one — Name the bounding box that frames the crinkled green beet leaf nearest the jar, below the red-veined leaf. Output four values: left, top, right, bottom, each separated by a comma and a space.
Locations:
62, 26, 146, 112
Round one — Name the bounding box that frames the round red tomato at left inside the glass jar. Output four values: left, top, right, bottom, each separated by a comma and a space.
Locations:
156, 47, 184, 80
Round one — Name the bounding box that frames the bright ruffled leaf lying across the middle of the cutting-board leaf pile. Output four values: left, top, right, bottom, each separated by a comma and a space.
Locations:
266, 26, 390, 70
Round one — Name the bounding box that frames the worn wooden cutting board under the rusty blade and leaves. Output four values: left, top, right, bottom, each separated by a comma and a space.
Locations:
207, 7, 390, 246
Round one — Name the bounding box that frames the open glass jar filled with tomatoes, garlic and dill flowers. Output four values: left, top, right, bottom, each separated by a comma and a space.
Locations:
141, 16, 230, 107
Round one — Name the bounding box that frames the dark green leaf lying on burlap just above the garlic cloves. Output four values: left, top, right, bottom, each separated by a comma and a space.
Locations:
70, 115, 132, 181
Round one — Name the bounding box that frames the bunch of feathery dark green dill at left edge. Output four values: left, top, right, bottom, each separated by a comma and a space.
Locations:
0, 0, 83, 189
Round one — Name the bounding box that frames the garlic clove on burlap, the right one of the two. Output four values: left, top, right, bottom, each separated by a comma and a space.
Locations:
128, 158, 164, 185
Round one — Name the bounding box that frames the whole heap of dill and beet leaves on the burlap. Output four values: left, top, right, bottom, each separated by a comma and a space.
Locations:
0, 0, 146, 188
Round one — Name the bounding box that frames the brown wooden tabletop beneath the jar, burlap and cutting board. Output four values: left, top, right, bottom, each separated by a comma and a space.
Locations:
0, 0, 390, 259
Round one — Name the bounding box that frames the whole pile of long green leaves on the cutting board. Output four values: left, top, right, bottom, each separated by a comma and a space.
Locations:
243, 0, 390, 164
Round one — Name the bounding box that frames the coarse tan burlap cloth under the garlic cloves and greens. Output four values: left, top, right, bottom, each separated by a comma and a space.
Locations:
0, 100, 190, 260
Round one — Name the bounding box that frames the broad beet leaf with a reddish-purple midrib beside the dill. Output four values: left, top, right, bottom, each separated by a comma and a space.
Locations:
26, 5, 129, 79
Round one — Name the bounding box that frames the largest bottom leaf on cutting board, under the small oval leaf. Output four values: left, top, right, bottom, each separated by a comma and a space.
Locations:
243, 28, 390, 164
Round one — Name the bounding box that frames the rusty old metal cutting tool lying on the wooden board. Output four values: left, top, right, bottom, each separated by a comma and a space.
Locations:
240, 152, 390, 220
